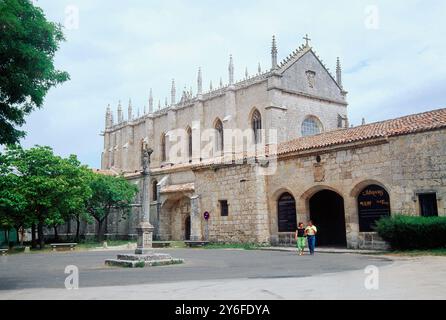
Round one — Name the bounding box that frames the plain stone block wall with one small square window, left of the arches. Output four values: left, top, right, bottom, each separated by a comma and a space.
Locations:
195, 165, 269, 243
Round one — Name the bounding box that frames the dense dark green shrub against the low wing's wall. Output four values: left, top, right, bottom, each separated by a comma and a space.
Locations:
376, 215, 446, 250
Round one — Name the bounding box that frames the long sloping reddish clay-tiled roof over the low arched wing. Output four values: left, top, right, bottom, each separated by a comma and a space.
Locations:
277, 109, 446, 155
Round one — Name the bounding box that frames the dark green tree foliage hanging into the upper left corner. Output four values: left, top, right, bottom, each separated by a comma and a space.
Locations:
0, 0, 69, 145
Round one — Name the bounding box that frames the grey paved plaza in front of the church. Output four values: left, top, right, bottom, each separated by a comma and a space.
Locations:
0, 249, 446, 300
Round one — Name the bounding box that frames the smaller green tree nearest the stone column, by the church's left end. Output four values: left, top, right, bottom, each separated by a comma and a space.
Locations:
87, 173, 138, 241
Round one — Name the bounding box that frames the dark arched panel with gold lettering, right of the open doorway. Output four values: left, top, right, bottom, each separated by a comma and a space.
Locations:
358, 184, 390, 232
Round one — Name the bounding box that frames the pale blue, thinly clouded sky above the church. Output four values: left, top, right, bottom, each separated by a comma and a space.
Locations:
22, 0, 446, 168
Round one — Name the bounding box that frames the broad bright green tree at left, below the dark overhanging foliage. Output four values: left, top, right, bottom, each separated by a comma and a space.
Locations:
3, 146, 91, 248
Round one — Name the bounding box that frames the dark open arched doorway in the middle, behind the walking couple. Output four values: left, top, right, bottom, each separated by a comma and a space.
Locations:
310, 190, 347, 247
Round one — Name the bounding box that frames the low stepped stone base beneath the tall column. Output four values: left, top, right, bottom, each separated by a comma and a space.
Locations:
105, 253, 184, 268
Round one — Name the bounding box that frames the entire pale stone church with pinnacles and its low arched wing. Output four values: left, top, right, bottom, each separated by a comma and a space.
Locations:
89, 39, 446, 248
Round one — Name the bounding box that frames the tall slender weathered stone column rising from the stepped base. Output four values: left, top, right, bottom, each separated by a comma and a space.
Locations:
135, 144, 154, 254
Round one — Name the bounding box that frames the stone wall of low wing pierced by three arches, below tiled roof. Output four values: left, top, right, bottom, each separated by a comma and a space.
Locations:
267, 130, 446, 248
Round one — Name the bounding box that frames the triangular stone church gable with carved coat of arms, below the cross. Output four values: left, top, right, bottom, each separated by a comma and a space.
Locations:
281, 50, 345, 101
